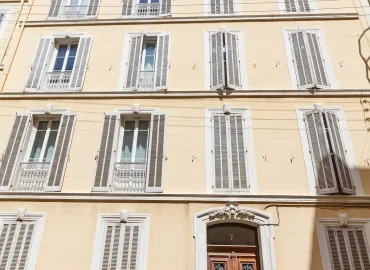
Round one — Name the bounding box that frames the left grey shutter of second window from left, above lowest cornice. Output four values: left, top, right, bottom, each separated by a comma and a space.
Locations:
93, 114, 120, 191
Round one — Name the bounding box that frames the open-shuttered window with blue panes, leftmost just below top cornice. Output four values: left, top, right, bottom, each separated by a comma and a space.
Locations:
26, 36, 92, 92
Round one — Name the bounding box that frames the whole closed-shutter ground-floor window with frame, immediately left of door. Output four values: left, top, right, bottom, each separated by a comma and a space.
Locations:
91, 215, 149, 270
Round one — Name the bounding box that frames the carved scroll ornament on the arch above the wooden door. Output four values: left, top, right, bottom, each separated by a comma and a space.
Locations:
209, 202, 255, 220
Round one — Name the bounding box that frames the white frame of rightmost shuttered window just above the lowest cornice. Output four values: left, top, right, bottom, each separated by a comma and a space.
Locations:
296, 106, 364, 196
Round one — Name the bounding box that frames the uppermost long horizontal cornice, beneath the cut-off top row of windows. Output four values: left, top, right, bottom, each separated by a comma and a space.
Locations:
25, 13, 359, 27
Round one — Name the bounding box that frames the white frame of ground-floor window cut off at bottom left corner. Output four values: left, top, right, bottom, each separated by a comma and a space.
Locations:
0, 212, 46, 270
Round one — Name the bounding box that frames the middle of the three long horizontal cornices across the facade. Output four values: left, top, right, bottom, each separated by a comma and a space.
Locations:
0, 89, 370, 100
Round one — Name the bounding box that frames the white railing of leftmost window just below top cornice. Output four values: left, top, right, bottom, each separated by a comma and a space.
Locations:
41, 71, 72, 92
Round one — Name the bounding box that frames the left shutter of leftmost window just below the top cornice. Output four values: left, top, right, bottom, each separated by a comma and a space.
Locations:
26, 37, 54, 90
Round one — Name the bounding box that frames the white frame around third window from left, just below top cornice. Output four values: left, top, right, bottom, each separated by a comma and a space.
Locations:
204, 28, 248, 91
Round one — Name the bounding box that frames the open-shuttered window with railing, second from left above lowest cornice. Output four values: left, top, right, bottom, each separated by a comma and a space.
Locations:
93, 109, 166, 193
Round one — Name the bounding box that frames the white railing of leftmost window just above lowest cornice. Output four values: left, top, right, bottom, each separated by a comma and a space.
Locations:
14, 162, 50, 191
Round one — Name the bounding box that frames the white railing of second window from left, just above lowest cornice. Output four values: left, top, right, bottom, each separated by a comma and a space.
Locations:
112, 163, 146, 192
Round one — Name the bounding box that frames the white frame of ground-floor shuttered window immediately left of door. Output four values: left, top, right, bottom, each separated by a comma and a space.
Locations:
90, 214, 150, 270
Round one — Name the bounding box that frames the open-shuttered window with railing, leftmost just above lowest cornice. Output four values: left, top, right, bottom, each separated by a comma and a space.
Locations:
0, 110, 76, 192
